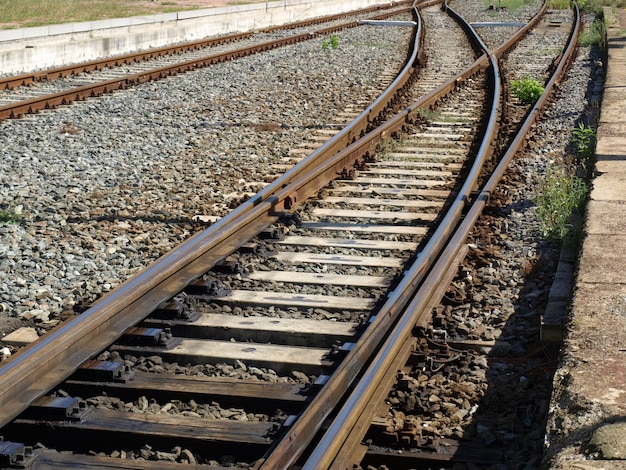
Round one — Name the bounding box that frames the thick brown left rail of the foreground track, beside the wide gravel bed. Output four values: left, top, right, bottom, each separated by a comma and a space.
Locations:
0, 0, 428, 427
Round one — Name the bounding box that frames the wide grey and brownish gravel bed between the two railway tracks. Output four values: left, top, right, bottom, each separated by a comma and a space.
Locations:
0, 20, 410, 346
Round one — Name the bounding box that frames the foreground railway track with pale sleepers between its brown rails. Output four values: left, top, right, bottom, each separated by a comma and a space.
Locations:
0, 0, 576, 468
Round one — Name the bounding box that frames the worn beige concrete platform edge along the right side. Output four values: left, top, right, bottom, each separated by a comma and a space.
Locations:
544, 7, 626, 470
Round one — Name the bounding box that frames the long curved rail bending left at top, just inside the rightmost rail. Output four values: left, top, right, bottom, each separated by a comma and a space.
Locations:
261, 0, 501, 469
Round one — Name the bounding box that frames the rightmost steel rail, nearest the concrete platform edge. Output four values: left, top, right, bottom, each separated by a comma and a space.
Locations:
302, 3, 580, 469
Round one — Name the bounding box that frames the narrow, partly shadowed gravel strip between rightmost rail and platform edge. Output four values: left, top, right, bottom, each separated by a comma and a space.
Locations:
448, 2, 604, 469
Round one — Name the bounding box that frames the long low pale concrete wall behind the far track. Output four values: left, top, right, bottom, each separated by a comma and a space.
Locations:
0, 0, 390, 74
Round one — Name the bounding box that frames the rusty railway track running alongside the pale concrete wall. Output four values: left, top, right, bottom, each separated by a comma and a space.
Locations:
0, 2, 410, 120
